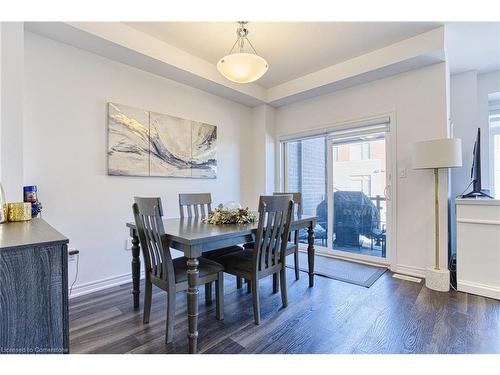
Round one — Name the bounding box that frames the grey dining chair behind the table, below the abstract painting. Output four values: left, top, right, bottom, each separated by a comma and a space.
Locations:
179, 193, 242, 303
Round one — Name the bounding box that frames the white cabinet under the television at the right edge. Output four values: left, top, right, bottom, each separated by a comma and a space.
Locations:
456, 199, 500, 299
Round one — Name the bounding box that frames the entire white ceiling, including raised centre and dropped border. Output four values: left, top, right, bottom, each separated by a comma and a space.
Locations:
25, 22, 500, 107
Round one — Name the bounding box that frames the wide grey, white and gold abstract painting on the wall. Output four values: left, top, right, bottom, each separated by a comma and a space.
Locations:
108, 103, 217, 178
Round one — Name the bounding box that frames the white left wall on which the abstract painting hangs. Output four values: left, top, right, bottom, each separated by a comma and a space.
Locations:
24, 33, 252, 296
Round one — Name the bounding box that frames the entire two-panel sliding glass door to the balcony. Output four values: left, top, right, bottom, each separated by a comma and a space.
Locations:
282, 121, 391, 262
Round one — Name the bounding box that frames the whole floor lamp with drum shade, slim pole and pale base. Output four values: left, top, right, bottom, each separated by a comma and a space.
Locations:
412, 138, 462, 292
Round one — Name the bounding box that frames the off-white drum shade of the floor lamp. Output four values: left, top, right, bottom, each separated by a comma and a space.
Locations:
412, 138, 462, 169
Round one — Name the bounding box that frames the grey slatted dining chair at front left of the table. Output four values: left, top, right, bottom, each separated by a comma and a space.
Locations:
132, 197, 224, 343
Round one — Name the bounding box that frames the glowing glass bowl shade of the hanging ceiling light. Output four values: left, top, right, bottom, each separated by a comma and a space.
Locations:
217, 53, 269, 83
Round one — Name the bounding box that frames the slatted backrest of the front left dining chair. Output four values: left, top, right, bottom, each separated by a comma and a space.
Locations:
132, 197, 175, 283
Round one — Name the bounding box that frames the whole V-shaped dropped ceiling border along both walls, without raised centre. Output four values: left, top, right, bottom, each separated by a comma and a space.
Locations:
25, 22, 445, 107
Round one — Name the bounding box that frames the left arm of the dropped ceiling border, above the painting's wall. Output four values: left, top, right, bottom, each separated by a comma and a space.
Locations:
25, 22, 267, 106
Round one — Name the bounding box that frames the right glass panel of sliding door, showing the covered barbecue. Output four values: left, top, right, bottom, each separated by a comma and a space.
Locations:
329, 131, 388, 258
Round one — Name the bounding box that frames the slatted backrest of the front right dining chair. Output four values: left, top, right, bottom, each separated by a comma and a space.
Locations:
253, 195, 293, 272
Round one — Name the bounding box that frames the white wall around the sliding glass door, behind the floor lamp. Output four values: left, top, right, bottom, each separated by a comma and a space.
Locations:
275, 63, 448, 276
